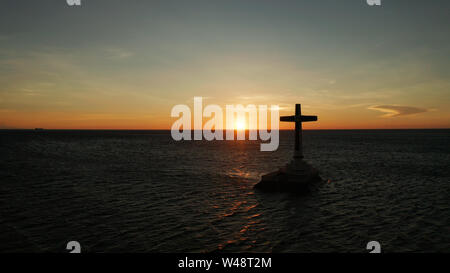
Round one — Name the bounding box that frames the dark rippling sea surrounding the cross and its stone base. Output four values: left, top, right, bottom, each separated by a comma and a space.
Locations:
0, 130, 450, 252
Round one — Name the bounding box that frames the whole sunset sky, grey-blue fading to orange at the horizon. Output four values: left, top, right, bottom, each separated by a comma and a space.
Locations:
0, 0, 450, 129
